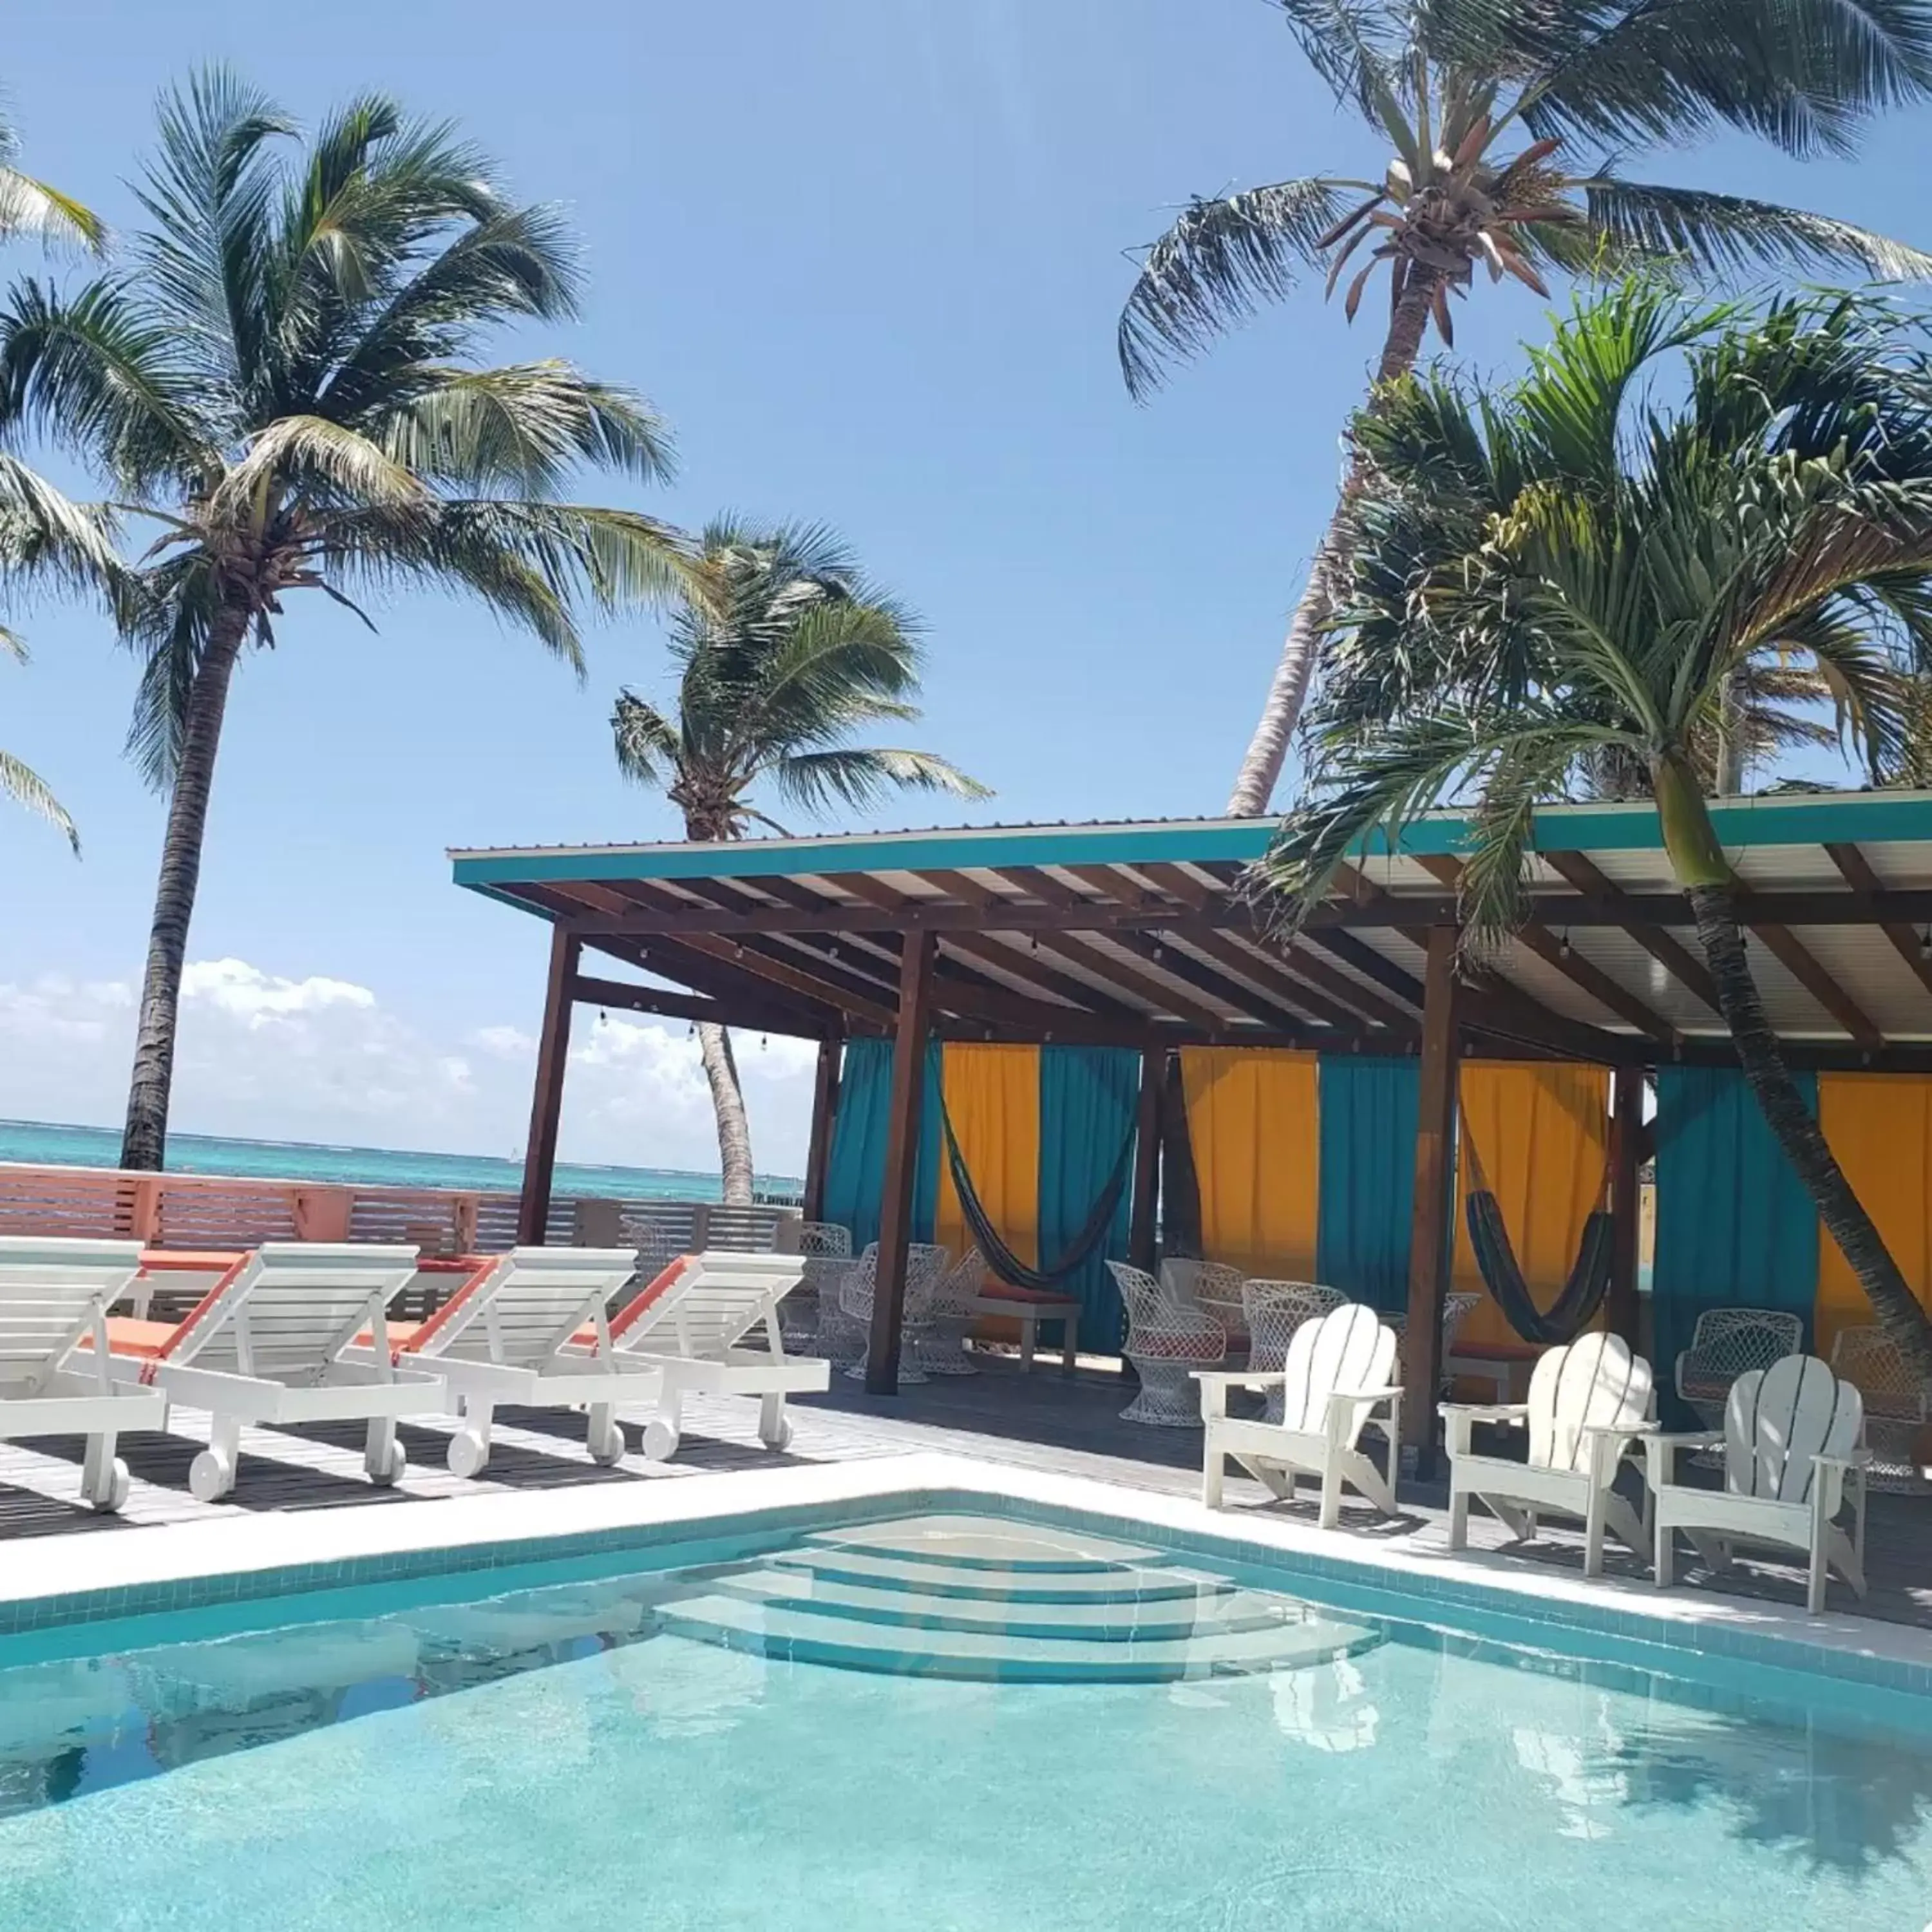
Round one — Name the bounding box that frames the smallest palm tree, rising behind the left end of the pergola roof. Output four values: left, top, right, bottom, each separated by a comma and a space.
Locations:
611, 516, 987, 1202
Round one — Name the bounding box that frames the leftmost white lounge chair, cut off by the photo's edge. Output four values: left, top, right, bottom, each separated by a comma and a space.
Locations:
0, 1235, 168, 1511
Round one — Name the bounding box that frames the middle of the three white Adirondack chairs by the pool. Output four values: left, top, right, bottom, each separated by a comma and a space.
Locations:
1441, 1335, 1656, 1577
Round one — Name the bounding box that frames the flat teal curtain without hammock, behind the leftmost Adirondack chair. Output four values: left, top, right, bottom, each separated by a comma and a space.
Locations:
1316, 1053, 1422, 1314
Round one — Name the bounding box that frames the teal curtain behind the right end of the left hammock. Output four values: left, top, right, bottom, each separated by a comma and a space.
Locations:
1039, 1047, 1140, 1354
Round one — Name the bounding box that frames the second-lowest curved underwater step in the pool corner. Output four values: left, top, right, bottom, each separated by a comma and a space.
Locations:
715, 1565, 1298, 1642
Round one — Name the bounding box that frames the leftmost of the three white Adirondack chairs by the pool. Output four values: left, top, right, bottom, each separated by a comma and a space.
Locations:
1194, 1302, 1403, 1530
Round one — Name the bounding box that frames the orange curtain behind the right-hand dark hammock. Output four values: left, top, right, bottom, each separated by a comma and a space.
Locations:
1455, 1061, 1609, 1345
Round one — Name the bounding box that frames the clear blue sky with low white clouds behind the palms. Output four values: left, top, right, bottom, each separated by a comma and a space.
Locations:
0, 0, 1932, 1167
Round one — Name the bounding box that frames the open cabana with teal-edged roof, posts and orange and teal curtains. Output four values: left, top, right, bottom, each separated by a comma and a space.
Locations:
452, 792, 1932, 1457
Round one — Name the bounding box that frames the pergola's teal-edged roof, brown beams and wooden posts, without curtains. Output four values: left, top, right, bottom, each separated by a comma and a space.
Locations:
450, 792, 1932, 1453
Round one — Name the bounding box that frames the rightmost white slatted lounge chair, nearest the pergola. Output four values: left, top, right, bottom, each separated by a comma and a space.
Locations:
611, 1250, 831, 1463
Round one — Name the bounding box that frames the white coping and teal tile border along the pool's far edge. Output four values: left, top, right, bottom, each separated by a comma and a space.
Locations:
0, 1453, 1932, 1698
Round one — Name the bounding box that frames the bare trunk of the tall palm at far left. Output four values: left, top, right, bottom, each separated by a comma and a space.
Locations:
122, 607, 249, 1173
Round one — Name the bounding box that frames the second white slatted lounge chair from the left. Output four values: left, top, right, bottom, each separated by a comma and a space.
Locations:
110, 1240, 446, 1503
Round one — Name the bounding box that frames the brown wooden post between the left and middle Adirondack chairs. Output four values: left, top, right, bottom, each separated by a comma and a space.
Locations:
1403, 925, 1457, 1480
